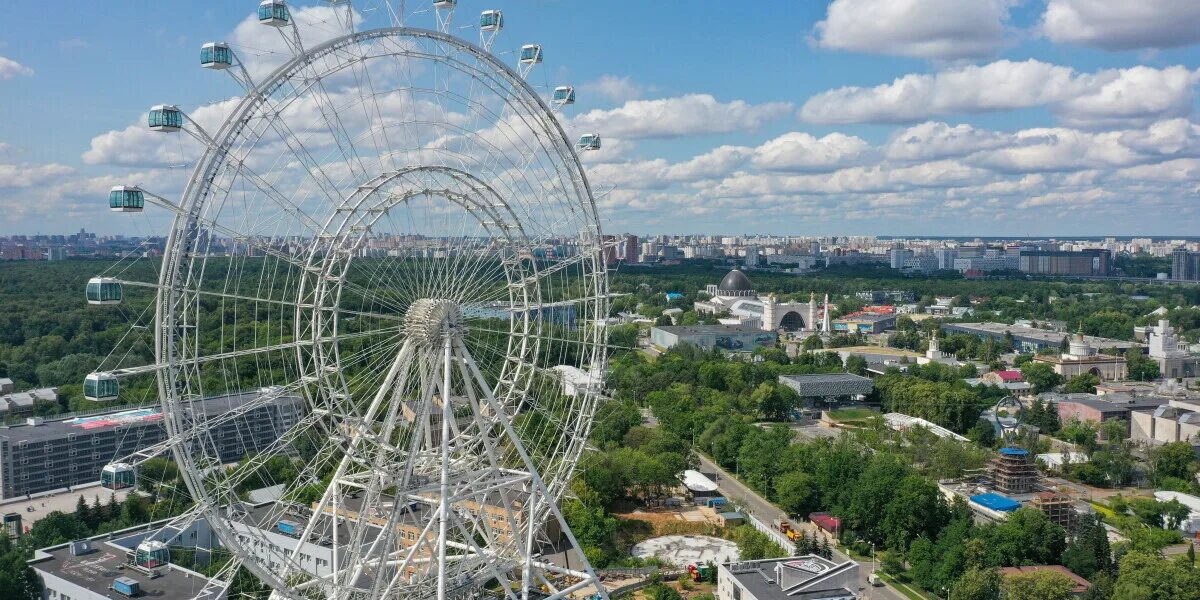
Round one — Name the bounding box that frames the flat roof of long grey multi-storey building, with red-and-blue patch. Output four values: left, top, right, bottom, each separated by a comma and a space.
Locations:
0, 390, 300, 443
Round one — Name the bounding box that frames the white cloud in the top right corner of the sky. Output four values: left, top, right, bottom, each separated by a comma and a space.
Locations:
1042, 0, 1200, 50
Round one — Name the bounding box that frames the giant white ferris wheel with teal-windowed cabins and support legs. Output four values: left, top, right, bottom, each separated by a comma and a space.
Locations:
84, 0, 610, 600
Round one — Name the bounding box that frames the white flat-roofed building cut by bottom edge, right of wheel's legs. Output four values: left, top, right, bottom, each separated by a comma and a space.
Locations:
716, 554, 858, 600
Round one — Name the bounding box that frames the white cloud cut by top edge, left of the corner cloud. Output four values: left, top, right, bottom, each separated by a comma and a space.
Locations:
814, 0, 1013, 59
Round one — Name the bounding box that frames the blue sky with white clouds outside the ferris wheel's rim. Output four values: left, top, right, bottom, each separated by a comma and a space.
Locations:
0, 0, 1200, 236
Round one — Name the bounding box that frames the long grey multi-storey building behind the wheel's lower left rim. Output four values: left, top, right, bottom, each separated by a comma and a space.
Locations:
0, 390, 304, 499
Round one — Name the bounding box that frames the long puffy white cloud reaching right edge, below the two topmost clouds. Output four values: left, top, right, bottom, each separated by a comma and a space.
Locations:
799, 59, 1196, 125
